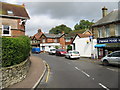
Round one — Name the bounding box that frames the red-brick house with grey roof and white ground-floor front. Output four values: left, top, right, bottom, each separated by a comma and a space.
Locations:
40, 32, 65, 51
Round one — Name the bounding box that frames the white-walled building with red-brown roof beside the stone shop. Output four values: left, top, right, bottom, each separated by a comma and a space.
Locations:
72, 34, 97, 57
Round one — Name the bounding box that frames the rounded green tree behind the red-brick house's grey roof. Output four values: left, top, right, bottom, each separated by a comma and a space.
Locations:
49, 24, 72, 34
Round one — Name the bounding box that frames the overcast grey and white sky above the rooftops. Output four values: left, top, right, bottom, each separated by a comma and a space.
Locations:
0, 0, 118, 36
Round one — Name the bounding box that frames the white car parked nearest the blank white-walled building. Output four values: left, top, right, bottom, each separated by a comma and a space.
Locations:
65, 50, 80, 59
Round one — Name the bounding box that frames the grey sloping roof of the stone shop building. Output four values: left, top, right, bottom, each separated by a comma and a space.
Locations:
93, 10, 120, 27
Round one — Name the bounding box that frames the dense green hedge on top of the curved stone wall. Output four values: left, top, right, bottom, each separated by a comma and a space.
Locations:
2, 36, 31, 67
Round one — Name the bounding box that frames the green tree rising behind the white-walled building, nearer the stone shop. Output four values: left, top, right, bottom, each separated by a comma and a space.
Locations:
74, 20, 94, 30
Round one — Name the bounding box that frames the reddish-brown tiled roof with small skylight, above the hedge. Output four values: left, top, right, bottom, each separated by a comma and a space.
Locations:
0, 2, 30, 19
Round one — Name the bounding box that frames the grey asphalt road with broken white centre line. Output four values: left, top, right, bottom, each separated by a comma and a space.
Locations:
35, 53, 120, 90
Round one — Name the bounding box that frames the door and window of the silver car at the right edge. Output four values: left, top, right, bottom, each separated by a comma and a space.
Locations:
109, 52, 120, 64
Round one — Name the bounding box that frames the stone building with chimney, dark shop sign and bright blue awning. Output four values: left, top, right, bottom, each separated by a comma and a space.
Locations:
92, 7, 120, 58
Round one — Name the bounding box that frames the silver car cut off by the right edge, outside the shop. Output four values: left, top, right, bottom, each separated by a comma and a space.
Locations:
101, 51, 120, 65
